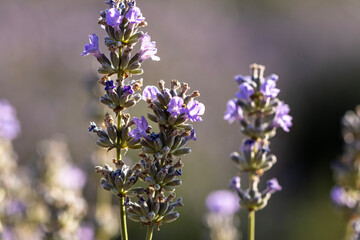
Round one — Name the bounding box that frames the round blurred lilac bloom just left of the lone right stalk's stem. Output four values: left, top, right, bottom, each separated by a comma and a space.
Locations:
206, 190, 240, 216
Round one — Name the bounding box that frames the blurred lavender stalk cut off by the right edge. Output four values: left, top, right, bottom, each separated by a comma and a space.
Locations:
331, 106, 360, 240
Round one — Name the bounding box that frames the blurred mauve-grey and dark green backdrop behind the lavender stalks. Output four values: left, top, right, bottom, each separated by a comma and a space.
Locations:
0, 0, 360, 240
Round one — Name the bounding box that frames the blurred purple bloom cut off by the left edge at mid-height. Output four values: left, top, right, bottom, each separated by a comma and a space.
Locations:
0, 100, 20, 140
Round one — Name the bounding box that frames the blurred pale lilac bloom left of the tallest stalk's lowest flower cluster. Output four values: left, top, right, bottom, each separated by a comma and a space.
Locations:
56, 164, 86, 190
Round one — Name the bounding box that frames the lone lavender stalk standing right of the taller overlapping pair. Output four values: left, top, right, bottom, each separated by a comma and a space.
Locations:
224, 64, 292, 240
